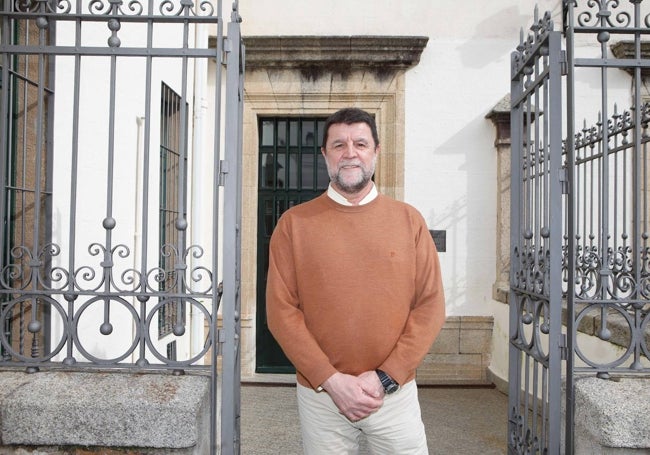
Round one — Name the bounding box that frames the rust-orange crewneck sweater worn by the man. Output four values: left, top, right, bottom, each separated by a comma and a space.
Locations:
266, 194, 445, 388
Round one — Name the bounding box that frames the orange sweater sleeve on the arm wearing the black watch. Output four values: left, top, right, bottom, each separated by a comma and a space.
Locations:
379, 213, 445, 384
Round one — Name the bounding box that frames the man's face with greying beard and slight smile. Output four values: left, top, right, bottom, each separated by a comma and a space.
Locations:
321, 122, 380, 194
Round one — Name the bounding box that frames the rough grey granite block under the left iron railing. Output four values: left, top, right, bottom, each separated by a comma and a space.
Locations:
0, 371, 210, 455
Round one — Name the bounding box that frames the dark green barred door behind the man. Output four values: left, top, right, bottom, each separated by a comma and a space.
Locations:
256, 117, 329, 373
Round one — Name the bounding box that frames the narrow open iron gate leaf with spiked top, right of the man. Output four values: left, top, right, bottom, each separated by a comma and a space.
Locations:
508, 8, 563, 453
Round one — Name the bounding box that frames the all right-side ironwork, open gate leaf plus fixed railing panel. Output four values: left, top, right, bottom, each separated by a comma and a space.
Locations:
508, 0, 650, 454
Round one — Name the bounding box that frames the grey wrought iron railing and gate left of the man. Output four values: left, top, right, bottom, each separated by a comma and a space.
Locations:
0, 0, 244, 454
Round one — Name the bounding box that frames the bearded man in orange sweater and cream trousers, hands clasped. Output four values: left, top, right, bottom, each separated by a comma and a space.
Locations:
266, 108, 445, 455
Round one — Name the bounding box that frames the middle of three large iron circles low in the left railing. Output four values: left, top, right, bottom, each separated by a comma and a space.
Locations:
72, 296, 142, 365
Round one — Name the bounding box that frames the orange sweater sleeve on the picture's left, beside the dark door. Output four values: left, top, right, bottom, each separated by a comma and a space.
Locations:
266, 216, 337, 388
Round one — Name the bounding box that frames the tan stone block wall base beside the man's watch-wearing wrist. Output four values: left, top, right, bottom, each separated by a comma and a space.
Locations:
416, 316, 494, 385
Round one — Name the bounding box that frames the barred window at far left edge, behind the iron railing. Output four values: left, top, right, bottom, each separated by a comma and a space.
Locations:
0, 21, 54, 360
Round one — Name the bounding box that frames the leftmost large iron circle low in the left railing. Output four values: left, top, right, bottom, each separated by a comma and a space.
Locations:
0, 294, 67, 363
